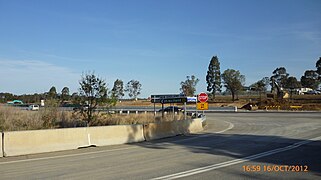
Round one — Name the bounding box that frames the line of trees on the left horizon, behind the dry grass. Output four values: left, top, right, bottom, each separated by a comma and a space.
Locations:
0, 75, 142, 106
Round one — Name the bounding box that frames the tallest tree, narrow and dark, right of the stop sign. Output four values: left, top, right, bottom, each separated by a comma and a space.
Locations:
206, 56, 222, 100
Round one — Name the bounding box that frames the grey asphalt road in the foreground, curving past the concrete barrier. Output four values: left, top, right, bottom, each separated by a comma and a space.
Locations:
0, 112, 321, 179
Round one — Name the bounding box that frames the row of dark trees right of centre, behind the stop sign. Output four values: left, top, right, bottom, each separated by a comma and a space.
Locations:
180, 56, 321, 101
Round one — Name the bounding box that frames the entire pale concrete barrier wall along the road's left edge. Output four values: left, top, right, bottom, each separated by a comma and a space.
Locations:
0, 119, 203, 157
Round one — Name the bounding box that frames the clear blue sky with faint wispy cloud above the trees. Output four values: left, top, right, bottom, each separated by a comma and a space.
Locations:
0, 0, 321, 98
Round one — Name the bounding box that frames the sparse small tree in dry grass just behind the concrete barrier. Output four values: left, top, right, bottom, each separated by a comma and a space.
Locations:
79, 72, 108, 124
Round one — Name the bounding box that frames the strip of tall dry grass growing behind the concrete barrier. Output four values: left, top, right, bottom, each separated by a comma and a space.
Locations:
0, 105, 184, 131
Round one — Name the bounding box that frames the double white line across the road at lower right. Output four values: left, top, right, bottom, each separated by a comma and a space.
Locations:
152, 136, 321, 180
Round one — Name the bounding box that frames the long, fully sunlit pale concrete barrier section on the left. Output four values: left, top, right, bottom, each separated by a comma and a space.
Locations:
4, 128, 90, 156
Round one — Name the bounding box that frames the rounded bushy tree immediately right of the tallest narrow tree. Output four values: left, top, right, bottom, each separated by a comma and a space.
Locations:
222, 69, 245, 101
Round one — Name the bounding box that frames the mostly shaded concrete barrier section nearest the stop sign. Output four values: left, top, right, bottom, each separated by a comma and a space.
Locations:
144, 118, 203, 141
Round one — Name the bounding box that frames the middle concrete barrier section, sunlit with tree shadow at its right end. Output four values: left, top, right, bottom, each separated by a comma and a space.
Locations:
87, 125, 145, 146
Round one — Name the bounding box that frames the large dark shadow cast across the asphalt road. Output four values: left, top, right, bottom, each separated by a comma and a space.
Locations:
135, 133, 321, 176
